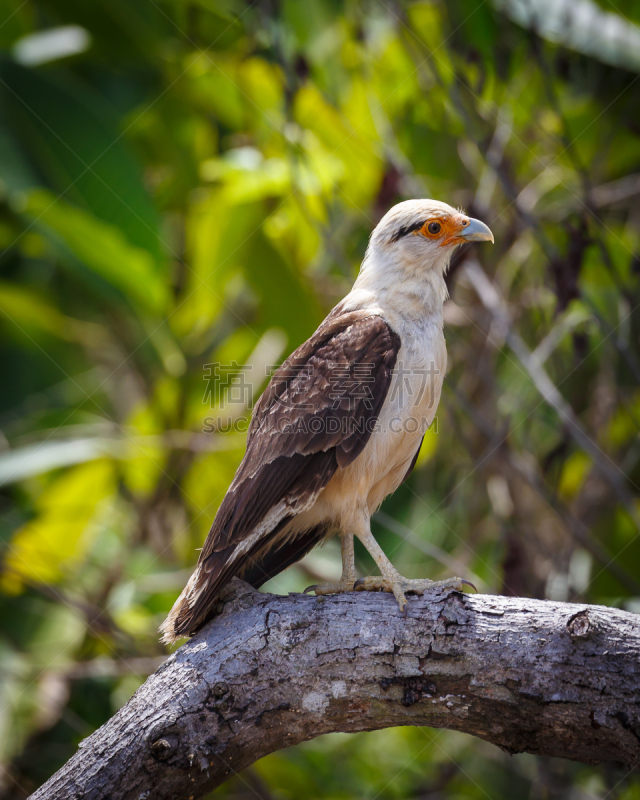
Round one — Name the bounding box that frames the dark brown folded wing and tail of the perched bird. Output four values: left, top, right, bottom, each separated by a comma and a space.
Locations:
167, 312, 400, 635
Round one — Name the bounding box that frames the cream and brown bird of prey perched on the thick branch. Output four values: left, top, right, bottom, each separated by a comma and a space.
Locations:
160, 199, 494, 643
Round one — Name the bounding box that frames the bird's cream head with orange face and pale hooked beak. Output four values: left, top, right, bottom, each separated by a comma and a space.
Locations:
371, 200, 493, 274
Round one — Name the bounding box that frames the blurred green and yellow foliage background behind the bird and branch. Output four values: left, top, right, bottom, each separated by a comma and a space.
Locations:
0, 0, 640, 800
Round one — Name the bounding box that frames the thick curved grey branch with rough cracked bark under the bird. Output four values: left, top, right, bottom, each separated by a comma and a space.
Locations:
32, 580, 640, 800
